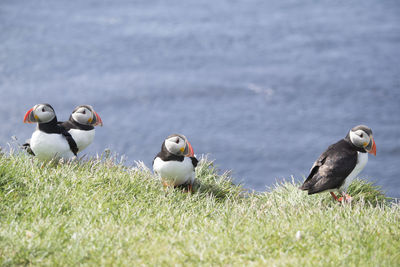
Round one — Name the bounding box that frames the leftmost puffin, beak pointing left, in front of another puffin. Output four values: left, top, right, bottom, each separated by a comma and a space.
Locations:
24, 104, 78, 160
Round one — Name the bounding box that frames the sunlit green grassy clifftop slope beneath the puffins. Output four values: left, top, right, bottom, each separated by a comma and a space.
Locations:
0, 154, 400, 266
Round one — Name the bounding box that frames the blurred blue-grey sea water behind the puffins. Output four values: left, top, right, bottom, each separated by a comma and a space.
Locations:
0, 0, 400, 197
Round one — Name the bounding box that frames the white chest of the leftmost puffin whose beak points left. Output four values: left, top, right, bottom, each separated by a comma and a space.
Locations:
30, 130, 74, 160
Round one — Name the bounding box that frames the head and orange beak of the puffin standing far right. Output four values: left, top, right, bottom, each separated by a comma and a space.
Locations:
346, 125, 376, 156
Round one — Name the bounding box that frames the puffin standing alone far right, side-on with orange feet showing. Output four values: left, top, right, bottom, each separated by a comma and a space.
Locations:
300, 125, 376, 202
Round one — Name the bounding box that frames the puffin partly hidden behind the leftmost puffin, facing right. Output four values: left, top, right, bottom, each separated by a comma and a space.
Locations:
60, 105, 103, 152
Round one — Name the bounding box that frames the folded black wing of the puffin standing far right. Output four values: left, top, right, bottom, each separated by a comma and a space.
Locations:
300, 139, 357, 195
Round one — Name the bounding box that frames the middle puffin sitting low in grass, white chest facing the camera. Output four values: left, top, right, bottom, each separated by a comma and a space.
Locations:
153, 134, 198, 192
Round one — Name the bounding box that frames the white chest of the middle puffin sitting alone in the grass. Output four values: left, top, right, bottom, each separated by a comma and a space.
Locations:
153, 157, 195, 185
